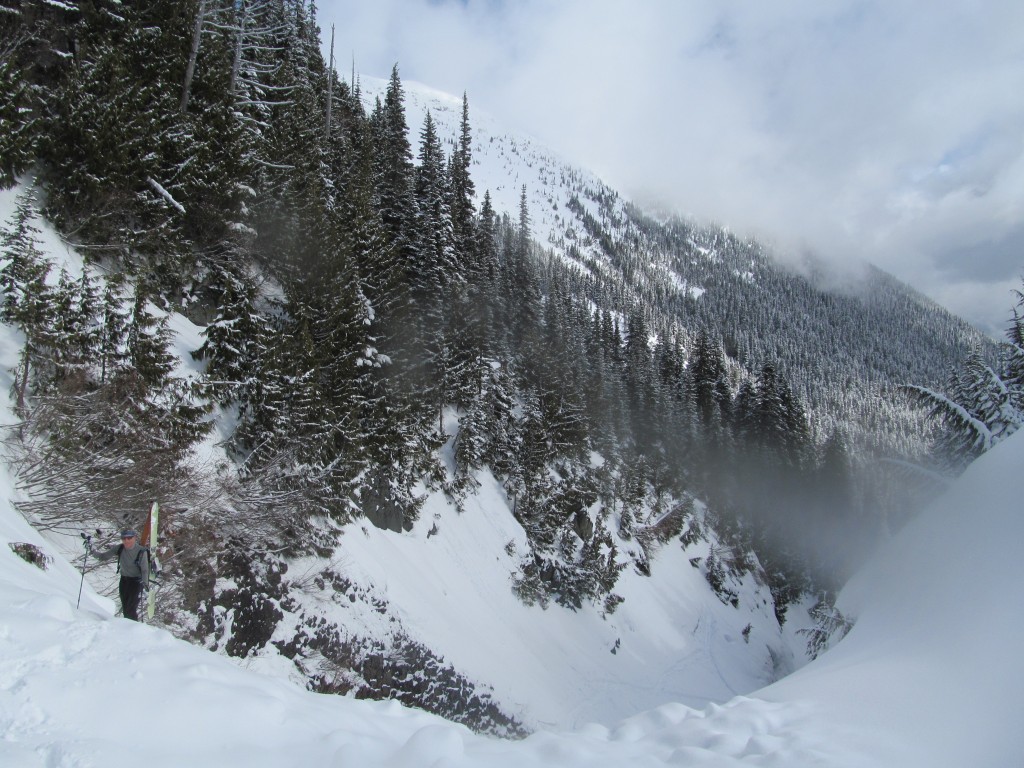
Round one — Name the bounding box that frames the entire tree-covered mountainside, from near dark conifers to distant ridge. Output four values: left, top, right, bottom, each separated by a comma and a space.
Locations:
0, 0, 987, 732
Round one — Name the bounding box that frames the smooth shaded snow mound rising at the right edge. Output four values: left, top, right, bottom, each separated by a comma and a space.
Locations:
759, 423, 1024, 767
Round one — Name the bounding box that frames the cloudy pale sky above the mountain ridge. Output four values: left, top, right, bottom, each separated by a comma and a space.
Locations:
317, 0, 1024, 337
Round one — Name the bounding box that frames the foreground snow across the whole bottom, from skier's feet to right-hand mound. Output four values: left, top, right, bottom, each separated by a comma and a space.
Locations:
0, 403, 1024, 768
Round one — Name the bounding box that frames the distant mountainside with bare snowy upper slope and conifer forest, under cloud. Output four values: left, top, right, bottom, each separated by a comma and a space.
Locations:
385, 78, 991, 455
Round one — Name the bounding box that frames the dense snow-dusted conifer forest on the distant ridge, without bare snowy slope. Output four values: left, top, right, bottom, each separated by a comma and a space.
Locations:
559, 185, 995, 456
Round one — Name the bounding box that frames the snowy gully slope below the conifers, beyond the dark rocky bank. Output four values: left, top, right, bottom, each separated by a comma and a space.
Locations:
296, 430, 790, 728
